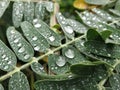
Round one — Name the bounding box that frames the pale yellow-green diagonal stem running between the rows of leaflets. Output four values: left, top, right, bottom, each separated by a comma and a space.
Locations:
0, 35, 85, 82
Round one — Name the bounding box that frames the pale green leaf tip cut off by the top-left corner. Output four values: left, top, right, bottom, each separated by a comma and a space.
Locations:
0, 0, 10, 18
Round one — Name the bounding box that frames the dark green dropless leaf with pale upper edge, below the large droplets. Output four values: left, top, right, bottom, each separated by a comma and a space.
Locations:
70, 61, 104, 76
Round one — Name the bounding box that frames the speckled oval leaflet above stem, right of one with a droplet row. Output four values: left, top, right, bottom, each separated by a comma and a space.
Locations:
21, 21, 50, 52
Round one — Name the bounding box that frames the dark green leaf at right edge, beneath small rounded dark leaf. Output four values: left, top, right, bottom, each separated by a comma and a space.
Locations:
84, 41, 120, 58
